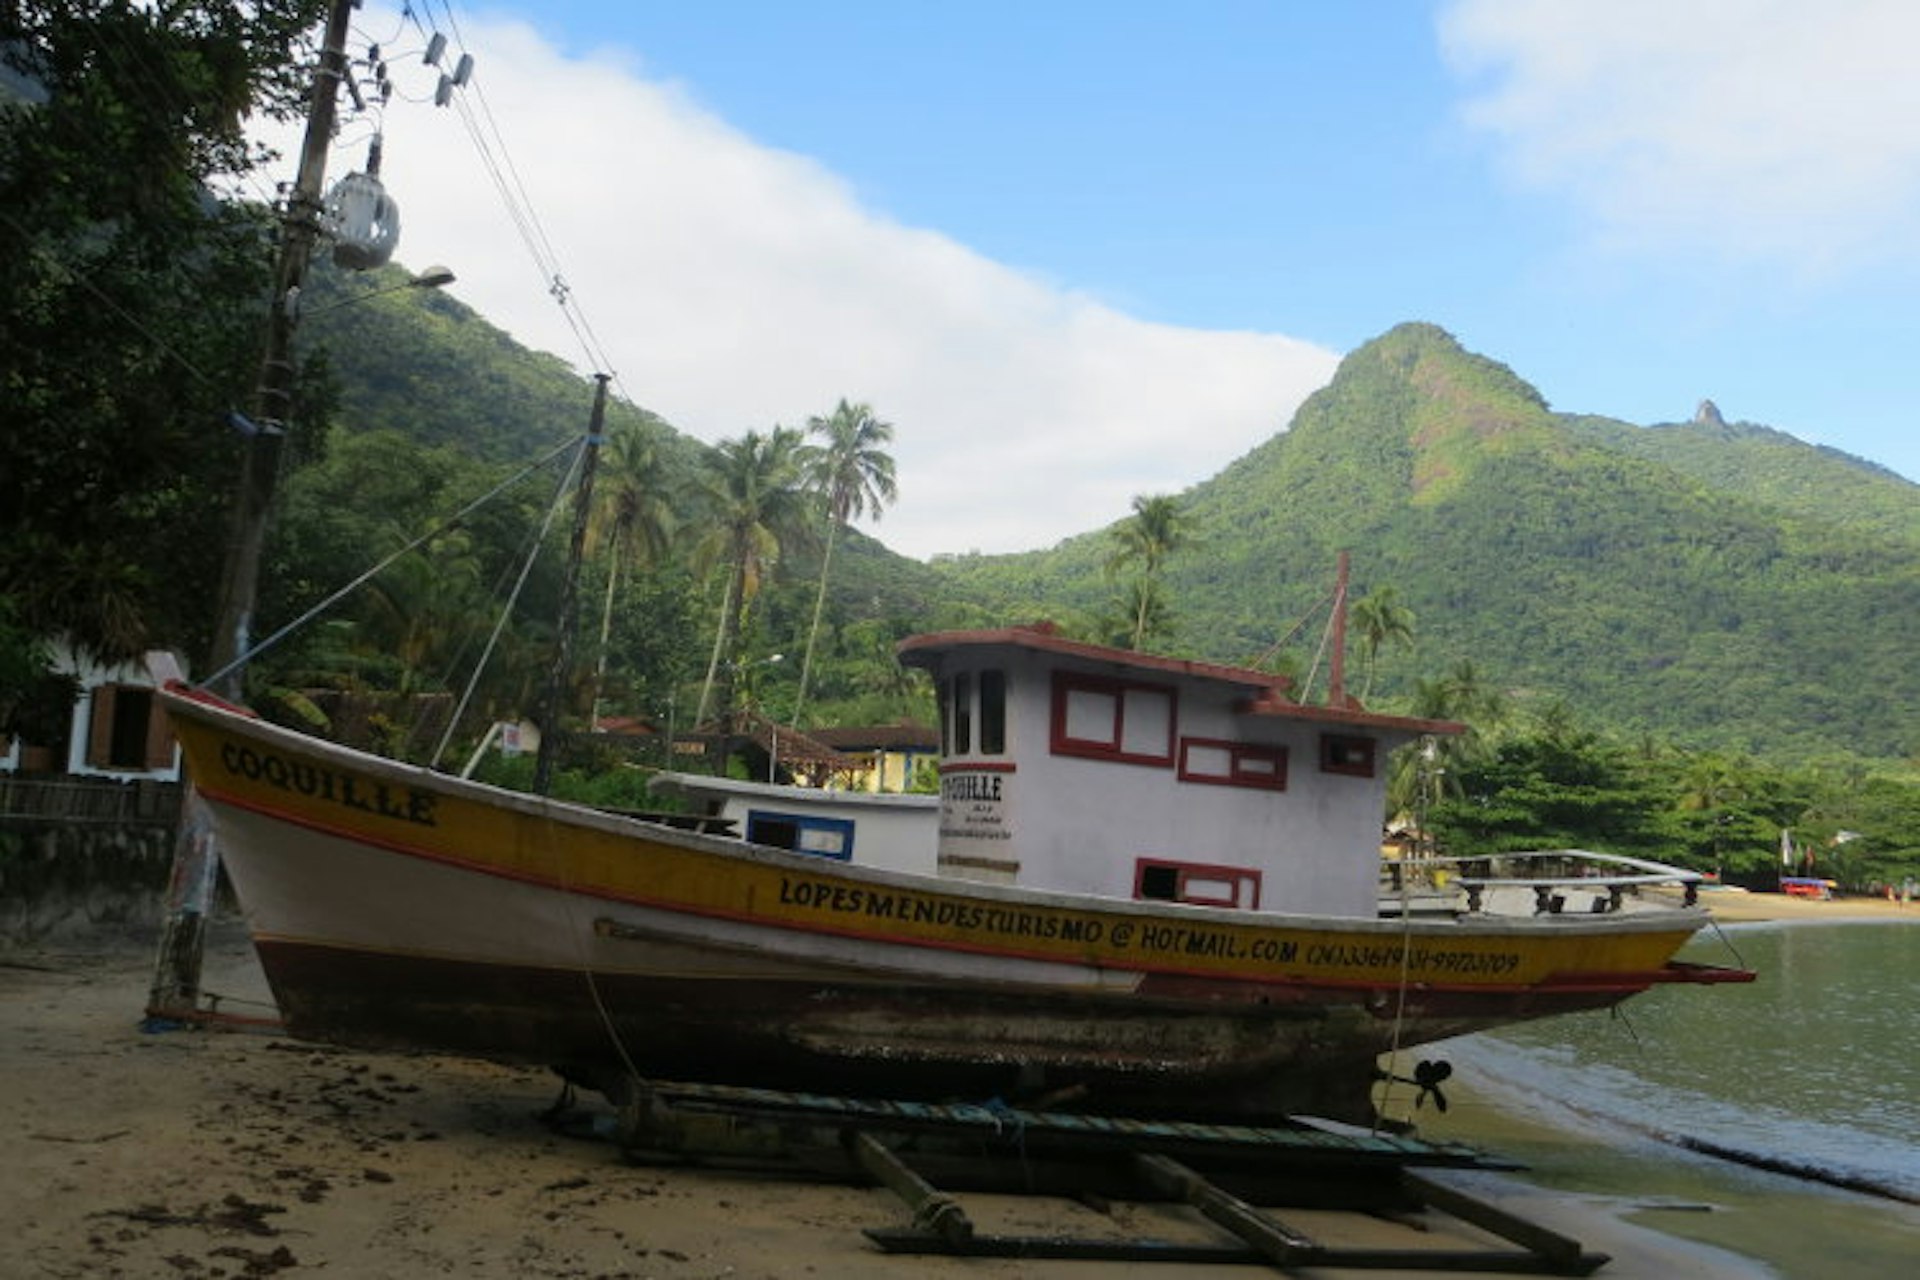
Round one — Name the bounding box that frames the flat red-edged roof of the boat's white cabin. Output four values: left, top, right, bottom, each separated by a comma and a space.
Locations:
897, 622, 1467, 735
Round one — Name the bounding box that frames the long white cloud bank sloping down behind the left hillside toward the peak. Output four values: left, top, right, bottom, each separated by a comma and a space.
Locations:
291, 10, 1336, 557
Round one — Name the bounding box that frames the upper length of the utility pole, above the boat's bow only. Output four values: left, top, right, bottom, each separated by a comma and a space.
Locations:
209, 0, 353, 699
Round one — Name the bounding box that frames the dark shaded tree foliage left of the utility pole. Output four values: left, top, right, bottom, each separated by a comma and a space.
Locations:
0, 0, 332, 658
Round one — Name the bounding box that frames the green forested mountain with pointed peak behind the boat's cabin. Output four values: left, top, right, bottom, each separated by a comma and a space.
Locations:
941, 324, 1920, 758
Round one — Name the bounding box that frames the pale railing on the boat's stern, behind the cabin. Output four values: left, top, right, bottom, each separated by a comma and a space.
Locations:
1394, 848, 1705, 915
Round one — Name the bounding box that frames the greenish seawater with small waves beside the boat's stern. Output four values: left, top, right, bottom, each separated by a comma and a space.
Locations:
1417, 924, 1920, 1280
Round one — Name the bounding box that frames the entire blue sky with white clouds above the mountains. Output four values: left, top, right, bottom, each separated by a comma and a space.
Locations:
284, 0, 1920, 558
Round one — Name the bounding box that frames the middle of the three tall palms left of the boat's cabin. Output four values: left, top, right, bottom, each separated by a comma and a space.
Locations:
693, 426, 806, 740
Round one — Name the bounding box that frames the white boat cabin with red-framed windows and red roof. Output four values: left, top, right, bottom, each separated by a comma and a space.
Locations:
900, 624, 1461, 917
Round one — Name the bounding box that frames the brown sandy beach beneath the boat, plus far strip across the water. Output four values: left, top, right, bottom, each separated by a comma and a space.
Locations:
0, 892, 1920, 1280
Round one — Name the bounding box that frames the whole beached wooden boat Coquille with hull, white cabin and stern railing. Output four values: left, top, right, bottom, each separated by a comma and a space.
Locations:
163, 628, 1753, 1119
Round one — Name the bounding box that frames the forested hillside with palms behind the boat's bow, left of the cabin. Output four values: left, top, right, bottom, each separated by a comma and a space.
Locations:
257, 267, 970, 752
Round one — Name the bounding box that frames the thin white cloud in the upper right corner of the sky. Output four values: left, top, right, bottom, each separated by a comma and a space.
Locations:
1440, 0, 1920, 273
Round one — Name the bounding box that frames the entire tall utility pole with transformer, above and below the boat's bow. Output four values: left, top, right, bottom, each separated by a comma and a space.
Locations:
146, 0, 353, 1019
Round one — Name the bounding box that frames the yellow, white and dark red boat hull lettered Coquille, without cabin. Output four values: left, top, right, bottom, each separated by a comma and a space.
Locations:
167, 693, 1728, 1119
